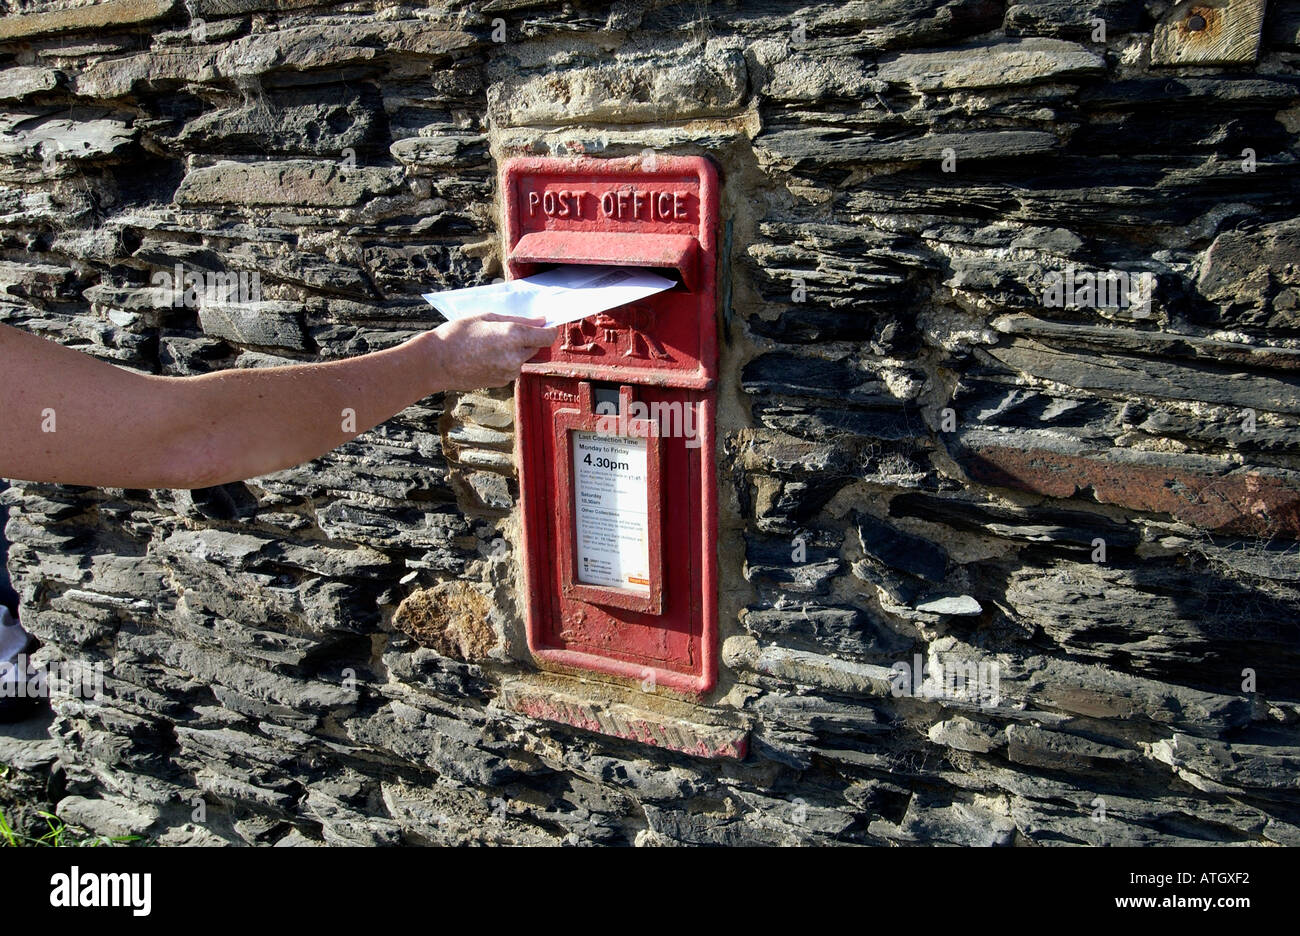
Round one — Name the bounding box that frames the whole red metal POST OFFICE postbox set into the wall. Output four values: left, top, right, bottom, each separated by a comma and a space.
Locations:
502, 156, 718, 696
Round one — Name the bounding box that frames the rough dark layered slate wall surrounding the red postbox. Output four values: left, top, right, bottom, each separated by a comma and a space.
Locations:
0, 0, 1300, 845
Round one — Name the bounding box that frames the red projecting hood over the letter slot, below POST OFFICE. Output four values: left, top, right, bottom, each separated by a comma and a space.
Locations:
510, 230, 699, 291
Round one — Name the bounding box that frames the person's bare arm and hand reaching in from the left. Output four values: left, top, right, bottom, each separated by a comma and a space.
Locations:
0, 316, 555, 489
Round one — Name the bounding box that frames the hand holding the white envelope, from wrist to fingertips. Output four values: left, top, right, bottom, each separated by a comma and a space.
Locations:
428, 313, 559, 390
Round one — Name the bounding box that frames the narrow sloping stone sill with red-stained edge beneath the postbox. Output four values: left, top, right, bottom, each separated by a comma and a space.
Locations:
499, 673, 749, 761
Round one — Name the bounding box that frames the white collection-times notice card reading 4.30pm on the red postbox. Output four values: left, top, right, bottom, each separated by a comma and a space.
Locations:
572, 432, 650, 594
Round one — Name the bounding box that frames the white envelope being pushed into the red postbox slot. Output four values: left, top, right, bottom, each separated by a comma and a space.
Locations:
424, 265, 677, 325
